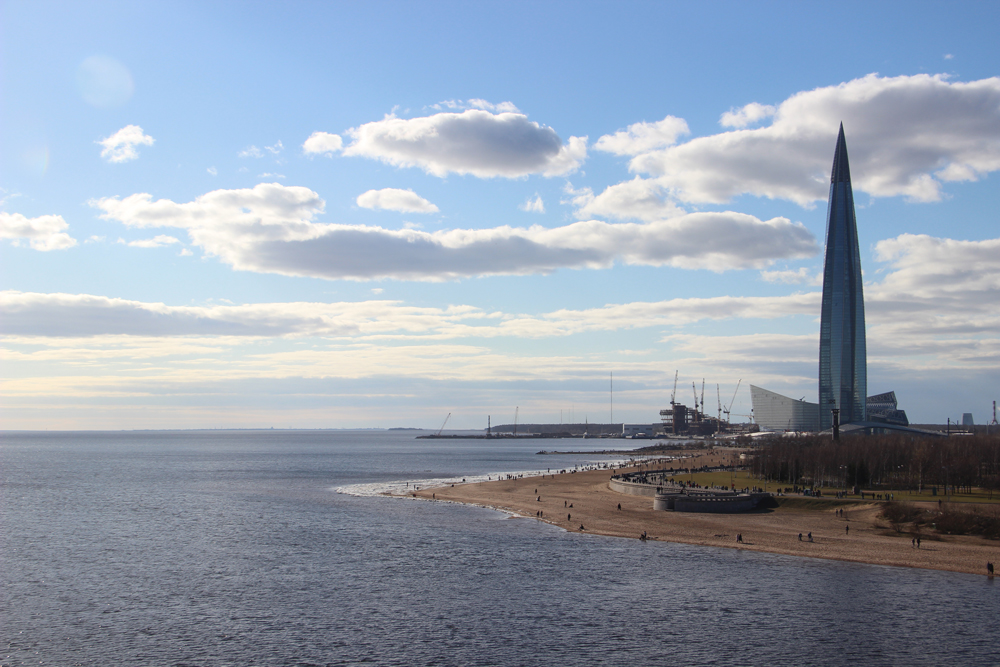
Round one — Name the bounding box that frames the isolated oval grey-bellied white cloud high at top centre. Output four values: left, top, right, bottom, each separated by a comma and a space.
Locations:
343, 109, 587, 178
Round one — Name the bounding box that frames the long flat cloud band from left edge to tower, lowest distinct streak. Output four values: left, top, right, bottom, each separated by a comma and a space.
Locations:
0, 288, 820, 338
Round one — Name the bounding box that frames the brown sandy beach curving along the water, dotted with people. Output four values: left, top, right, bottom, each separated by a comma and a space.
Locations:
415, 459, 1000, 575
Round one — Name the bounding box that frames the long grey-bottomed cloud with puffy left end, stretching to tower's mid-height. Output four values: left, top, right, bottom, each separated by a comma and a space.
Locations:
91, 183, 818, 280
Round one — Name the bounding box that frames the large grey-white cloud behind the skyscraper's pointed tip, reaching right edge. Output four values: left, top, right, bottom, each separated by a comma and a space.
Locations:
629, 74, 1000, 206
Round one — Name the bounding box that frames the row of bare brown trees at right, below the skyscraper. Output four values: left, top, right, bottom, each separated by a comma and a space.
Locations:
749, 435, 1000, 497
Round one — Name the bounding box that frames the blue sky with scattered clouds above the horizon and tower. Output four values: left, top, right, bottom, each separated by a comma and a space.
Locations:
0, 1, 1000, 429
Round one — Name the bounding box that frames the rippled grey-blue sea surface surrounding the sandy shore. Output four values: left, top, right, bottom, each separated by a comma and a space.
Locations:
0, 431, 1000, 667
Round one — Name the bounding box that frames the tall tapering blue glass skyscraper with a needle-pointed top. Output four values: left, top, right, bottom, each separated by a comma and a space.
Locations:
819, 123, 868, 429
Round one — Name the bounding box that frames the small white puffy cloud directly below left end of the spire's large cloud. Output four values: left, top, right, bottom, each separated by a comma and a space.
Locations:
564, 176, 684, 221
